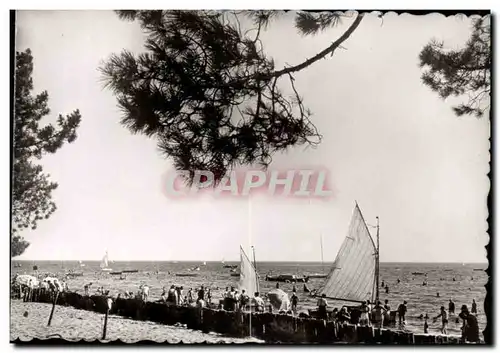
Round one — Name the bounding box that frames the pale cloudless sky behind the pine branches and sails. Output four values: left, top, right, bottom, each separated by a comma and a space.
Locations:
16, 11, 490, 262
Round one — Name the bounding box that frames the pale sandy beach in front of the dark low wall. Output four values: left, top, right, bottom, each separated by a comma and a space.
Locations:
10, 300, 263, 343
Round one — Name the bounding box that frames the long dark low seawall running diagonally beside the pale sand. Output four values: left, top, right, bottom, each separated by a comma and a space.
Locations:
16, 290, 460, 345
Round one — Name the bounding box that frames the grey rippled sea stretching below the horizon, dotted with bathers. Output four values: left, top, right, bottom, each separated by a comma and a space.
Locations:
11, 260, 488, 335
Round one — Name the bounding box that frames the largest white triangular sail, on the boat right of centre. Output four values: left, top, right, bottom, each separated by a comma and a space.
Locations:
317, 204, 377, 302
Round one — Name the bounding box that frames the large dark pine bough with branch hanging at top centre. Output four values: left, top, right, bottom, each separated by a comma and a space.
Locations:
100, 11, 360, 183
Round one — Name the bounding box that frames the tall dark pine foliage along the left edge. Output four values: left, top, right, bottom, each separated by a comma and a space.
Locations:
11, 49, 81, 256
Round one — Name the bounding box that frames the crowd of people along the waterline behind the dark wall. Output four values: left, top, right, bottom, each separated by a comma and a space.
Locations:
13, 275, 479, 341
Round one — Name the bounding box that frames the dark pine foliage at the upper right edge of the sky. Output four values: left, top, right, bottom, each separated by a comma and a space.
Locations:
419, 17, 491, 118
